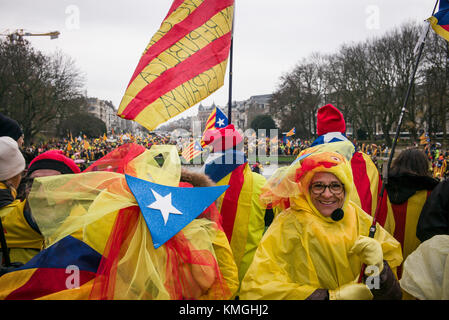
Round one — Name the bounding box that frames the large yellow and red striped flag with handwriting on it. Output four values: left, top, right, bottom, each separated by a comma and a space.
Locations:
117, 0, 234, 130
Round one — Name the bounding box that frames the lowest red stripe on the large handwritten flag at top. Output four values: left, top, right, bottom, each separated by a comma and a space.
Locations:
122, 32, 231, 120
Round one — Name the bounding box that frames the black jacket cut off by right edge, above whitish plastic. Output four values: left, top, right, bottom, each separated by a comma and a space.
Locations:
416, 179, 449, 242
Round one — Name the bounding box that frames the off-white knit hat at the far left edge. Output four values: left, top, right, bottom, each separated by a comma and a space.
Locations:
0, 137, 25, 181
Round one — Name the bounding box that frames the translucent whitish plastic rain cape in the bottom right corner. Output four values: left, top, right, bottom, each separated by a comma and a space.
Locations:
399, 235, 449, 300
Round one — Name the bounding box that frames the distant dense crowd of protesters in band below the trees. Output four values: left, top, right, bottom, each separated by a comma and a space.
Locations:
13, 133, 449, 180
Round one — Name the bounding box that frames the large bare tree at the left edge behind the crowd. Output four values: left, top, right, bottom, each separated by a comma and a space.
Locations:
0, 40, 83, 144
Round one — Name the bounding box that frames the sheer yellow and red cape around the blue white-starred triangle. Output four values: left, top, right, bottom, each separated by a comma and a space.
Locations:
29, 144, 238, 299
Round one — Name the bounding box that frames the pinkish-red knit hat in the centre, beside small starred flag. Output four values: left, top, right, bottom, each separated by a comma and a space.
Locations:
203, 124, 242, 152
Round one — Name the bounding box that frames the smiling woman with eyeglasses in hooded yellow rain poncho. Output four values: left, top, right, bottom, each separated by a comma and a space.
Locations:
240, 151, 402, 300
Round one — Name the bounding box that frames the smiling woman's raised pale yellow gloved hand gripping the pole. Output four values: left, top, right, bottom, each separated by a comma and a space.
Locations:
349, 236, 384, 276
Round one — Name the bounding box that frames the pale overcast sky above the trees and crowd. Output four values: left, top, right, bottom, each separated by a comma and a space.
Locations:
0, 0, 435, 122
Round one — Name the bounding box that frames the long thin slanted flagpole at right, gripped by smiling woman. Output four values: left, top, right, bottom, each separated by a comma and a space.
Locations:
359, 0, 439, 282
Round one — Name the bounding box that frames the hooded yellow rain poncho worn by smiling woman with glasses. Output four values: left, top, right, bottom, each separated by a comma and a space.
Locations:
240, 152, 402, 300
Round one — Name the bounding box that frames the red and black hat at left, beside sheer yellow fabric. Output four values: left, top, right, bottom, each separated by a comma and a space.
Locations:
28, 150, 81, 175
